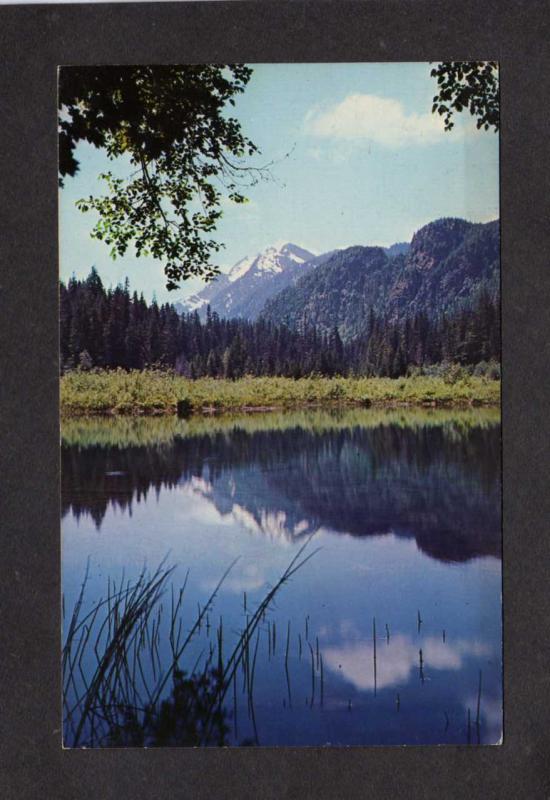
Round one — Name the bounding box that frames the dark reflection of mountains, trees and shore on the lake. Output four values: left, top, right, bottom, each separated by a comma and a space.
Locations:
62, 410, 501, 562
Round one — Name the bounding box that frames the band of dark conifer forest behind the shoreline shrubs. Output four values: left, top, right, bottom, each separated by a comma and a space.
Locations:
60, 270, 500, 379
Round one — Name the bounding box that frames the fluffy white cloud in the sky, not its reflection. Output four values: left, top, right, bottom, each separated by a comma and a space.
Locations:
305, 94, 452, 147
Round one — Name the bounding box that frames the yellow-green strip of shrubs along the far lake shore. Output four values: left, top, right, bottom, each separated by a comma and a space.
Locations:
61, 369, 500, 416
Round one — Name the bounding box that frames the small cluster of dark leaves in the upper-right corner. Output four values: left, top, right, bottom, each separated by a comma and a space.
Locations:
430, 61, 500, 131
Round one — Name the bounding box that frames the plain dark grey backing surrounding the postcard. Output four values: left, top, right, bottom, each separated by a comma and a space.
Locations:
0, 0, 550, 800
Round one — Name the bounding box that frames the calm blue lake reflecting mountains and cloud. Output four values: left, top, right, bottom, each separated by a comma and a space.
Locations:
62, 409, 502, 746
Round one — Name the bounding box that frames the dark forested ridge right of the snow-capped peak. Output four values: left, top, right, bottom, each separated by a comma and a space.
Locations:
261, 217, 500, 340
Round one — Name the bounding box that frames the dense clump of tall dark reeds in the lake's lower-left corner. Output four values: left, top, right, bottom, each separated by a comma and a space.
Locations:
62, 539, 317, 747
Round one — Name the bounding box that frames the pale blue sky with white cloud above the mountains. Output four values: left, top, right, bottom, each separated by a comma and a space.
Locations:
59, 63, 499, 302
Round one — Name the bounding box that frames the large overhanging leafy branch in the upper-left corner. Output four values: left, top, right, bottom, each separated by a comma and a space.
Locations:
59, 64, 263, 289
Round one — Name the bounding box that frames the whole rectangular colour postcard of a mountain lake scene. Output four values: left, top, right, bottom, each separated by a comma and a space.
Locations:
59, 61, 503, 748
